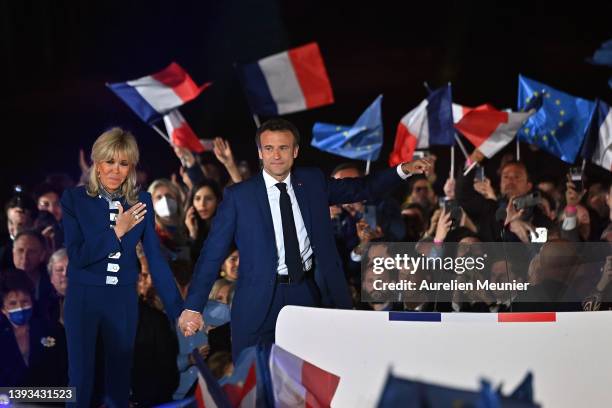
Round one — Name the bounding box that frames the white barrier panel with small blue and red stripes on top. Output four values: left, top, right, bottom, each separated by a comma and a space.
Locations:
276, 306, 612, 408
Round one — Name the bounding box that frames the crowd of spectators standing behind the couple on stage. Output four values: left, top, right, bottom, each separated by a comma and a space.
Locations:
0, 122, 612, 406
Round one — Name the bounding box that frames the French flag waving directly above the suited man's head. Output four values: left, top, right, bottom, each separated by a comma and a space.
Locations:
240, 43, 334, 116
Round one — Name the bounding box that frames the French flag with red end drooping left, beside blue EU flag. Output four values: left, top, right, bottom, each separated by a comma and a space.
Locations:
389, 84, 455, 166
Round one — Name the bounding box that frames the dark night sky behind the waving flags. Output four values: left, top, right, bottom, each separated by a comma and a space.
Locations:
0, 0, 612, 201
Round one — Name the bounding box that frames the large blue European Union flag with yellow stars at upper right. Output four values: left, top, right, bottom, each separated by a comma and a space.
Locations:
518, 75, 595, 163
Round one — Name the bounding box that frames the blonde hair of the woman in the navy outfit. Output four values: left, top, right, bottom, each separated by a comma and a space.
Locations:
86, 127, 140, 205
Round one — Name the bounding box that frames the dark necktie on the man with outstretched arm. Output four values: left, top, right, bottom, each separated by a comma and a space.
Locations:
276, 183, 304, 282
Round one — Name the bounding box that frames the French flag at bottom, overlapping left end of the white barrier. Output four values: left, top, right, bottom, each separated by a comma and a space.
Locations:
270, 344, 340, 408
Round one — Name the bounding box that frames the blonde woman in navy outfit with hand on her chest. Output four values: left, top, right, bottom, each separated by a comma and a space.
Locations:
61, 128, 182, 407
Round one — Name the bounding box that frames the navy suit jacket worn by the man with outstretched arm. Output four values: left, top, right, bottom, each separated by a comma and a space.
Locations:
185, 168, 402, 331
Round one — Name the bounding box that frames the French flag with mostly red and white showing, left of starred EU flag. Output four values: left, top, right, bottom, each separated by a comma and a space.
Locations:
453, 104, 535, 159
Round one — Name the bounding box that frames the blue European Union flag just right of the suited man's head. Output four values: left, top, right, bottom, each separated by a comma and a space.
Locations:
310, 95, 383, 161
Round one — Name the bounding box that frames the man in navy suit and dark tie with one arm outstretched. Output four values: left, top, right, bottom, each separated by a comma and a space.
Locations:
179, 118, 431, 358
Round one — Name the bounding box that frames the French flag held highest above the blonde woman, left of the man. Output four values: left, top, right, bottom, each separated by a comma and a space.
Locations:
106, 62, 211, 123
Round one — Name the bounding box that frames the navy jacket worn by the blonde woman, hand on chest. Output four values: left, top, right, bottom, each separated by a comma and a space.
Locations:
61, 186, 182, 318
